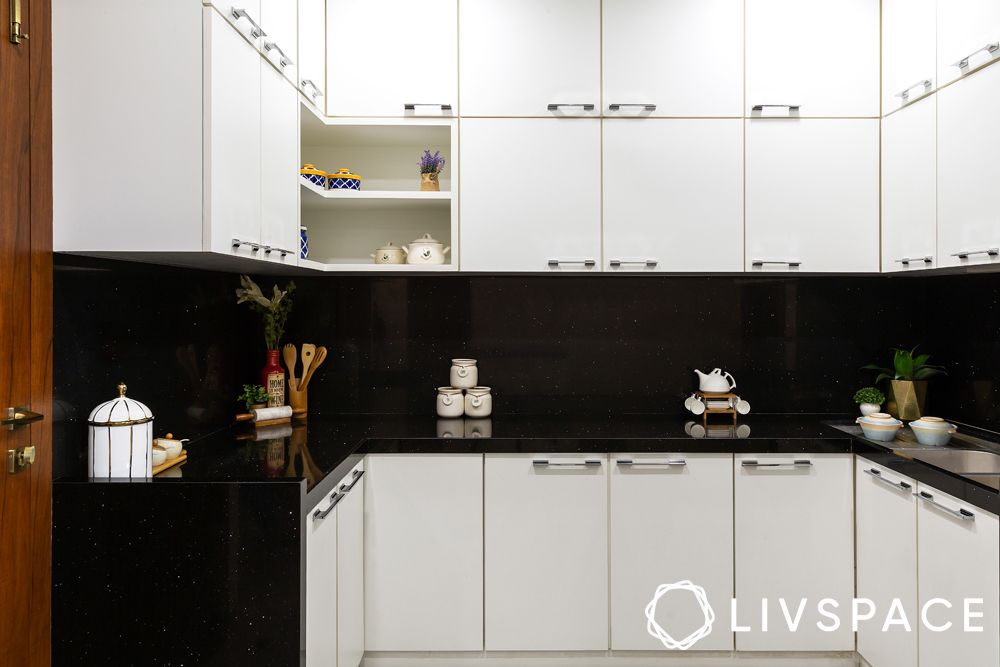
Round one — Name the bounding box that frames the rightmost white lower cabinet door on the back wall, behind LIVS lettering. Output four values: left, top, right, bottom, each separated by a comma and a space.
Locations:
733, 454, 854, 651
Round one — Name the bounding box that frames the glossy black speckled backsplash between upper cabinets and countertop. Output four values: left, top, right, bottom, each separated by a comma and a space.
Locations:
54, 255, 1000, 476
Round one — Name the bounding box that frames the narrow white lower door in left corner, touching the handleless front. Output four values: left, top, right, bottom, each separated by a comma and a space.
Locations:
337, 466, 365, 667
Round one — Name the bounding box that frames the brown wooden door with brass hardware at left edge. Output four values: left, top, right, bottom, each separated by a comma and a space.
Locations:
0, 0, 52, 667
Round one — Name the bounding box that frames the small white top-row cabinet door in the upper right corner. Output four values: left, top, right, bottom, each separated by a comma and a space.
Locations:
937, 0, 1000, 85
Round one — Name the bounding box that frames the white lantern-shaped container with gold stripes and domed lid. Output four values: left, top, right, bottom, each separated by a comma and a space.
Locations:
87, 384, 153, 479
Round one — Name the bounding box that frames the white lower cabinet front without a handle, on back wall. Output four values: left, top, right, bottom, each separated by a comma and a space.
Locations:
364, 454, 483, 651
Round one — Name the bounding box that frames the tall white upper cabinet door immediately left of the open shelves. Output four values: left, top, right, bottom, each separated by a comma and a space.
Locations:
260, 61, 301, 266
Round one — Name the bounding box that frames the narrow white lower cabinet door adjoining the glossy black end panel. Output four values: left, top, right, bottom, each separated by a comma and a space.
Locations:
305, 493, 338, 667
